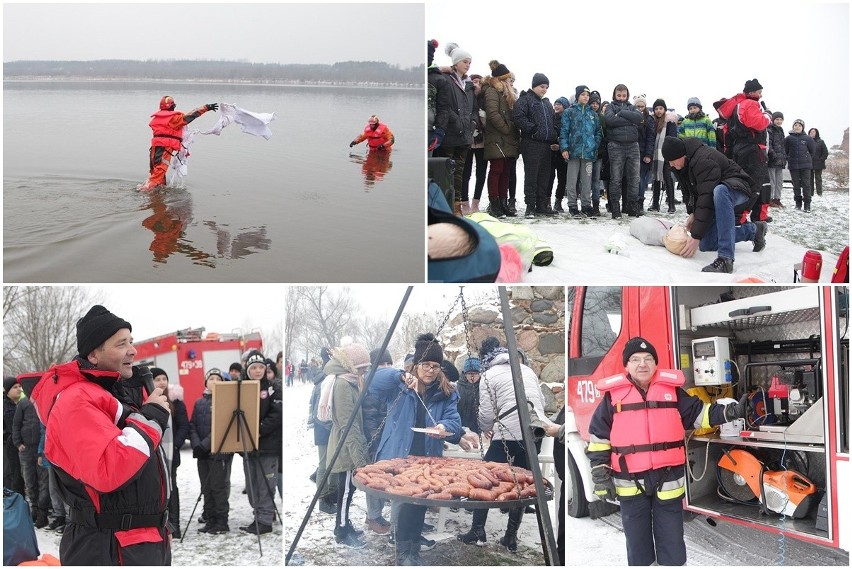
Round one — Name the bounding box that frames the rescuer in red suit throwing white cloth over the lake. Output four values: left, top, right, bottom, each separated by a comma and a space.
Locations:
142, 95, 219, 190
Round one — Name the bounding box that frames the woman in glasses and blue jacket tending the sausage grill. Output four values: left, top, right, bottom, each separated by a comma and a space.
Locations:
368, 334, 462, 565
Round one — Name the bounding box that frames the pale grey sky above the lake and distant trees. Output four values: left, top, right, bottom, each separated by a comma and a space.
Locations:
3, 2, 425, 68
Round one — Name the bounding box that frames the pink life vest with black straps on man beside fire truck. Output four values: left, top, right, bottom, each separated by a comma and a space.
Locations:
597, 369, 686, 474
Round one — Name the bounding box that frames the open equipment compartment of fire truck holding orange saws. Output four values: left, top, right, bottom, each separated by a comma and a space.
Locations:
672, 287, 848, 542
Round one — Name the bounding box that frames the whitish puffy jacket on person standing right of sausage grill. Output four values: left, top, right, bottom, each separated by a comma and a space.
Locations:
479, 353, 544, 441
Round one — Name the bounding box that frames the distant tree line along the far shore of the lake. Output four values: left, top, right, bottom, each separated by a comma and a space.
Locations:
3, 59, 426, 87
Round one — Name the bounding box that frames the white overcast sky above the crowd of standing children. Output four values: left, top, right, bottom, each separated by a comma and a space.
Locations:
426, 0, 850, 147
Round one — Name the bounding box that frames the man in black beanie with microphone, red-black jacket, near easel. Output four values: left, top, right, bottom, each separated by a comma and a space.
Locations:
32, 305, 171, 565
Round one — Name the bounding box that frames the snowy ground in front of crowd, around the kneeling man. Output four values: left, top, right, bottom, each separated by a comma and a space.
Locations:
481, 181, 849, 285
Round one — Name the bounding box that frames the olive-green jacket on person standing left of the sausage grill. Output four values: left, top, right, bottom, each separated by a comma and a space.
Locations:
324, 358, 370, 474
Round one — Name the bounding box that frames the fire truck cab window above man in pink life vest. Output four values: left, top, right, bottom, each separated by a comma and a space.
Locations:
581, 287, 622, 357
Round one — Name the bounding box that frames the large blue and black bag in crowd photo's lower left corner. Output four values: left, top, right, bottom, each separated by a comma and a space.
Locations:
428, 182, 500, 283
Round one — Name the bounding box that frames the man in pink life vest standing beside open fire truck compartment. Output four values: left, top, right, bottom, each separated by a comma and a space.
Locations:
586, 336, 748, 565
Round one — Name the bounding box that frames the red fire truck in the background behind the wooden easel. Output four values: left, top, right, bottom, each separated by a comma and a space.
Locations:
134, 328, 263, 413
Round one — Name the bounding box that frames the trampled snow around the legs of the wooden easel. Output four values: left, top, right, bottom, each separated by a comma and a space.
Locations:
30, 448, 286, 567
